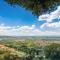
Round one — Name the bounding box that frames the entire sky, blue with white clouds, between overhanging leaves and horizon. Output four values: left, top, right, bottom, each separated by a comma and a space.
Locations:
0, 0, 60, 36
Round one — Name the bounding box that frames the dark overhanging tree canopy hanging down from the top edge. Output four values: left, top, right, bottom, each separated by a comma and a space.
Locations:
5, 0, 60, 16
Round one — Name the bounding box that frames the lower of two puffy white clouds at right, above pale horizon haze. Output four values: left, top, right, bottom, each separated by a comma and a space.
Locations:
40, 21, 60, 31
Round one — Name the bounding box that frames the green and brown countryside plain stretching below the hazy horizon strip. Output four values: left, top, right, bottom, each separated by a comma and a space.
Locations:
0, 37, 60, 60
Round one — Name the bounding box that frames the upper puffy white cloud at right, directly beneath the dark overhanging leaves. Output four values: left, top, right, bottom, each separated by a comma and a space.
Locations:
38, 6, 60, 22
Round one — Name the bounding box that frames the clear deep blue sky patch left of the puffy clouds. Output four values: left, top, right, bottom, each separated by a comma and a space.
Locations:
0, 0, 36, 25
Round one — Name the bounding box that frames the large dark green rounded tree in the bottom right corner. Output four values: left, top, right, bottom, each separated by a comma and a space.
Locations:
44, 44, 60, 60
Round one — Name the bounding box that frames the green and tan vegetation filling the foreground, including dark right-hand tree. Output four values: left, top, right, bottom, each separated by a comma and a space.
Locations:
0, 40, 60, 60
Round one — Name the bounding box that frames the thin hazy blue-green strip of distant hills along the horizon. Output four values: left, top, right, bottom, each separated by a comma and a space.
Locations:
0, 36, 60, 40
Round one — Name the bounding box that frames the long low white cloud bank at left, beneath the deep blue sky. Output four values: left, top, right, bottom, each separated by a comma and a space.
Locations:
0, 24, 35, 36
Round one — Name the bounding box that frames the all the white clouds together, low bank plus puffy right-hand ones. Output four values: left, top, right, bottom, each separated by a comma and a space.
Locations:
0, 6, 60, 36
